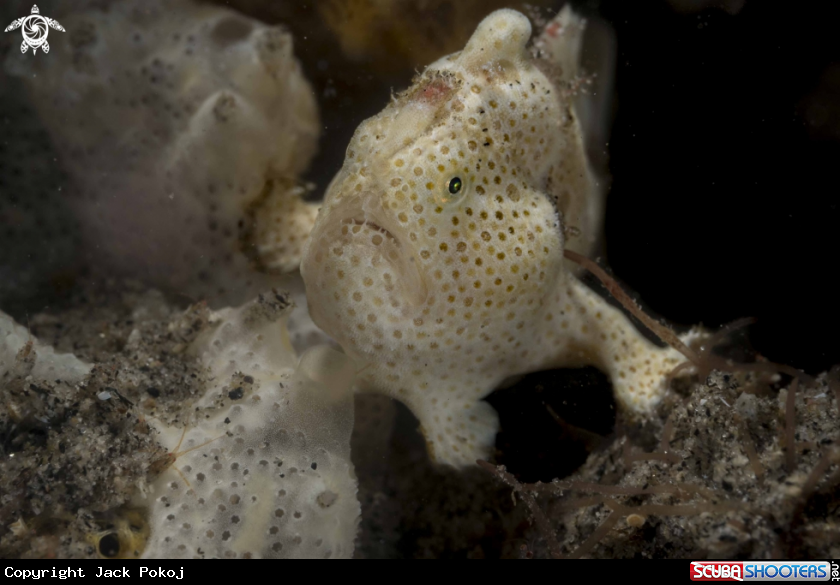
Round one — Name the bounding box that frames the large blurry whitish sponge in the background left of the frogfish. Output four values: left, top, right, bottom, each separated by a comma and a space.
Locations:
5, 0, 320, 307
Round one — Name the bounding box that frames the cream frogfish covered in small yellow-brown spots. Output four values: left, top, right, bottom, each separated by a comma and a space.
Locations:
301, 10, 680, 467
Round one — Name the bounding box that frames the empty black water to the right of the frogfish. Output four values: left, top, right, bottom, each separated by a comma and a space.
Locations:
599, 0, 840, 373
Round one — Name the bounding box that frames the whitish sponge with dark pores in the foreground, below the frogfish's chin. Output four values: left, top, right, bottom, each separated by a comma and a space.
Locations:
138, 295, 360, 558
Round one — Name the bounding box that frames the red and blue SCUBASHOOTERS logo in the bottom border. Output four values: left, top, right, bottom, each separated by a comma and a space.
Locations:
691, 561, 840, 582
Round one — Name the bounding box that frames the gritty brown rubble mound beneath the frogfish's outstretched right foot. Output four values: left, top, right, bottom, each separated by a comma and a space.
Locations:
508, 371, 840, 559
